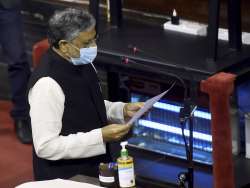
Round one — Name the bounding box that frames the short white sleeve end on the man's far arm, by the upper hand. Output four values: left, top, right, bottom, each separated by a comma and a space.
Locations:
104, 100, 126, 124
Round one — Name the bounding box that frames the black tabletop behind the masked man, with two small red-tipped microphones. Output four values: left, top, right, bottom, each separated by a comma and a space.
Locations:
98, 21, 250, 81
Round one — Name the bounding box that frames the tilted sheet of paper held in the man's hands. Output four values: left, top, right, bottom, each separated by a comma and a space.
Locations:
127, 89, 170, 125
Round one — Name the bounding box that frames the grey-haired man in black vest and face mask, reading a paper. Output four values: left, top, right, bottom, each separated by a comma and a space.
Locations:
28, 9, 143, 180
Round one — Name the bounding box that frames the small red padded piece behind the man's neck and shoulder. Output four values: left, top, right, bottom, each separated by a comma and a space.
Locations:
32, 39, 49, 68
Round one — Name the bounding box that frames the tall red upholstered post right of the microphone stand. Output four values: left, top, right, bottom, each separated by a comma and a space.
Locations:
201, 73, 235, 188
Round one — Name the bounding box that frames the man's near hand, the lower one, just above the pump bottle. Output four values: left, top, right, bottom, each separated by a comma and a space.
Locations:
102, 124, 132, 142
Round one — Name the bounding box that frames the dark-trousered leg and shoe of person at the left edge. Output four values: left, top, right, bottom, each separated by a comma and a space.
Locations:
0, 0, 32, 144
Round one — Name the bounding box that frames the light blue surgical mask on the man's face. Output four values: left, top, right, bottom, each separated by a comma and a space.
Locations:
71, 46, 97, 65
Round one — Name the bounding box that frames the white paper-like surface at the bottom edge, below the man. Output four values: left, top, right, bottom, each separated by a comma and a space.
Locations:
15, 179, 103, 188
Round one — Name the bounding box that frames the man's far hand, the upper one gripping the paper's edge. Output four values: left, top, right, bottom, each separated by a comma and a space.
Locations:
123, 102, 144, 121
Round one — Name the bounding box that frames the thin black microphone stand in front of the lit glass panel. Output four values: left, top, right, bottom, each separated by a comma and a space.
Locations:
178, 99, 197, 188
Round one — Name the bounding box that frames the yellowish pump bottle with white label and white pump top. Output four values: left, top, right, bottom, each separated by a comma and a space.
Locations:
117, 142, 135, 188
